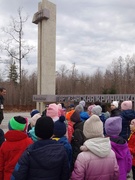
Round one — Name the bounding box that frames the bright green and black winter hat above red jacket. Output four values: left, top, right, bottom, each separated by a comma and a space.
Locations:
8, 116, 27, 131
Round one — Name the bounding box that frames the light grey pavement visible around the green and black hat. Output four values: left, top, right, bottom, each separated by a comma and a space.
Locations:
0, 112, 30, 132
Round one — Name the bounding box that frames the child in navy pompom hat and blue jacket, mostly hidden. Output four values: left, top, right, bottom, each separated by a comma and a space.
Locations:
52, 116, 72, 169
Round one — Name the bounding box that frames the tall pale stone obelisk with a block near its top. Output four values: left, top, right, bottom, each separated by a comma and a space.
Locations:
33, 0, 56, 112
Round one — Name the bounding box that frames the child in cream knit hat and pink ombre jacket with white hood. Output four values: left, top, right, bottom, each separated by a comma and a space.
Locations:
71, 115, 119, 180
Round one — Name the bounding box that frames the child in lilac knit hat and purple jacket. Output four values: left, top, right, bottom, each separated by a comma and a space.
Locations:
105, 116, 132, 180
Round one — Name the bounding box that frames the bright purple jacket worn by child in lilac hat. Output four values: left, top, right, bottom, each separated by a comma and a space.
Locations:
110, 136, 132, 180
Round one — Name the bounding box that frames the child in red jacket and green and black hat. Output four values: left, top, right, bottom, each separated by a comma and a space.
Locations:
0, 116, 33, 180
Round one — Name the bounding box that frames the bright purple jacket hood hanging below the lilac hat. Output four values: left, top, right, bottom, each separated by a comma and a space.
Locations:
111, 141, 128, 160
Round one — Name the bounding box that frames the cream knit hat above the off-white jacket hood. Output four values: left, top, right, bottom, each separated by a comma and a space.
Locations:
83, 115, 104, 139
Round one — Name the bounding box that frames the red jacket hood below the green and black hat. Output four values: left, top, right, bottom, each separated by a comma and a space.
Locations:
5, 130, 27, 142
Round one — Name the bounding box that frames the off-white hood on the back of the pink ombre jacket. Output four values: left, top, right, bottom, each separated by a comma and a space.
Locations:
84, 137, 111, 157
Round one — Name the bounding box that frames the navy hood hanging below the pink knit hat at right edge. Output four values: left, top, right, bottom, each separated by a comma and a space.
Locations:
121, 109, 135, 121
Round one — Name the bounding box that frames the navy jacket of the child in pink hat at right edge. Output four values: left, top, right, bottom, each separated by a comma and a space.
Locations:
120, 109, 135, 141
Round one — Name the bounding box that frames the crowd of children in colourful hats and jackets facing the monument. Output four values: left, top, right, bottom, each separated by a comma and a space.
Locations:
0, 100, 135, 180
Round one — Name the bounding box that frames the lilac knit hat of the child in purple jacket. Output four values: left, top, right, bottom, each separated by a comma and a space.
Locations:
105, 116, 122, 136
